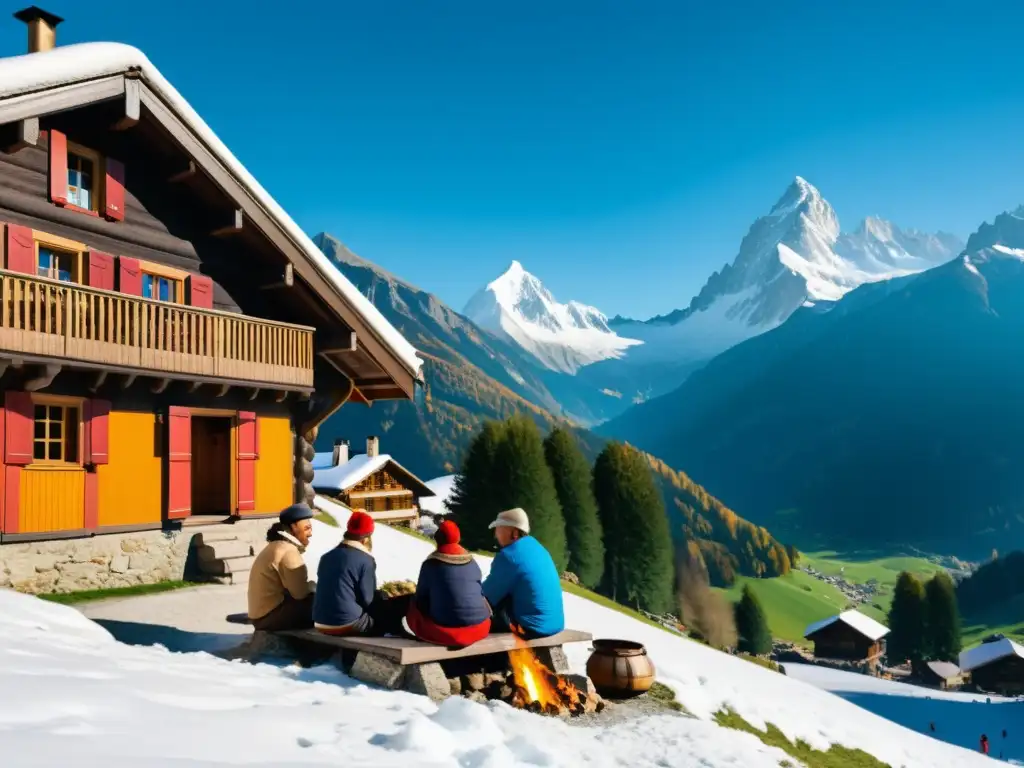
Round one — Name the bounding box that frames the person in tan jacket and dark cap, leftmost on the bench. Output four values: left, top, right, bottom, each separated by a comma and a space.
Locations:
248, 504, 316, 632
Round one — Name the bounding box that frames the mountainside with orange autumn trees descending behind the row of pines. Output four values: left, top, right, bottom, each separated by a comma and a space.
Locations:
314, 234, 790, 584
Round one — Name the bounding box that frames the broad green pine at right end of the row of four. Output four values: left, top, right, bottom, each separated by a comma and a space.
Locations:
594, 442, 673, 612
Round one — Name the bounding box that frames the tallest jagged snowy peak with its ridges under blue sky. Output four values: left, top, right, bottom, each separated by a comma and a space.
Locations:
612, 176, 963, 361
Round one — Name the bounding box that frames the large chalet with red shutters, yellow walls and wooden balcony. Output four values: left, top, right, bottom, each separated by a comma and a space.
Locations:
0, 7, 420, 592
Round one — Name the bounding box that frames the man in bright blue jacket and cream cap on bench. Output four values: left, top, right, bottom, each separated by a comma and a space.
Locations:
483, 508, 565, 639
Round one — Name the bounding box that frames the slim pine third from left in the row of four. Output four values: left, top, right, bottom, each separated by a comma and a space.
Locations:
544, 427, 604, 589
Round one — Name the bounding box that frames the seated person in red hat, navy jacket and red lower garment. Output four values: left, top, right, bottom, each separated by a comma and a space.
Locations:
406, 520, 490, 648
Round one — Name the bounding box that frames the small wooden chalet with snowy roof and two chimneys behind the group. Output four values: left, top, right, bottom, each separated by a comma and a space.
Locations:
313, 436, 434, 527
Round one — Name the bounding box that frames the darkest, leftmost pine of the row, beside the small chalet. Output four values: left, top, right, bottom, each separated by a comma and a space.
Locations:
447, 421, 505, 550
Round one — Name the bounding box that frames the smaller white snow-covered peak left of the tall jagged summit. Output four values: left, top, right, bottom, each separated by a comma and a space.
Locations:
463, 261, 639, 374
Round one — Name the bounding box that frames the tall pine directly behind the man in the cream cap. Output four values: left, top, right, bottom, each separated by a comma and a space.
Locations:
490, 415, 568, 572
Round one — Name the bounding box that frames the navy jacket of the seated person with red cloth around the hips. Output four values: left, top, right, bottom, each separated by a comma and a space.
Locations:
416, 552, 490, 628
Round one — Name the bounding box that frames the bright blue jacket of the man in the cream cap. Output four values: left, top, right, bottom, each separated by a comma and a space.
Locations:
483, 536, 565, 637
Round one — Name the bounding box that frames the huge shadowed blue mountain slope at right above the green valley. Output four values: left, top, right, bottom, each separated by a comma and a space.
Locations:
601, 209, 1024, 556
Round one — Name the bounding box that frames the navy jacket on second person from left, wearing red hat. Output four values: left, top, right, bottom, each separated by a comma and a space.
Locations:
313, 542, 377, 627
